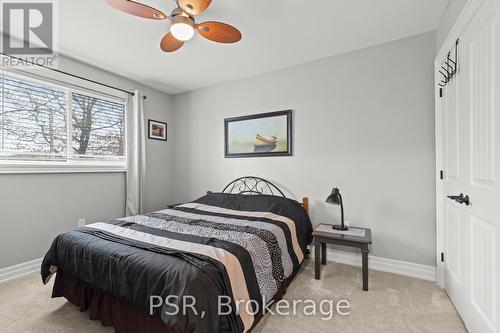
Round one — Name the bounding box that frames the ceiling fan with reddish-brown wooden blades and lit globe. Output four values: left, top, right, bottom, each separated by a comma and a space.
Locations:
107, 0, 241, 52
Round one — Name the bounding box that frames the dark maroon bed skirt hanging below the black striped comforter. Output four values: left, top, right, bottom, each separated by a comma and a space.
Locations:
52, 268, 300, 333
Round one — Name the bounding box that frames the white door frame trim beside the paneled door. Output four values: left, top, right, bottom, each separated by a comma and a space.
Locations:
434, 0, 484, 288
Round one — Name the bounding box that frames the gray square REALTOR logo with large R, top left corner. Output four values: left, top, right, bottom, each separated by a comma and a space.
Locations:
0, 0, 56, 67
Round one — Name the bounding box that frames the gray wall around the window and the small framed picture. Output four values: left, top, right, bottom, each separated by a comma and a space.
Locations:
0, 57, 173, 268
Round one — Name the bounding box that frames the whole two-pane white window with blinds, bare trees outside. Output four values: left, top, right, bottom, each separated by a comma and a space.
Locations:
0, 72, 125, 169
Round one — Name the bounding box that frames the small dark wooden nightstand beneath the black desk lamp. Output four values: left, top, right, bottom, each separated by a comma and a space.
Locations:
313, 224, 372, 291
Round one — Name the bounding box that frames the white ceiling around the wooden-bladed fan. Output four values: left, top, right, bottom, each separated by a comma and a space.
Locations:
53, 0, 449, 94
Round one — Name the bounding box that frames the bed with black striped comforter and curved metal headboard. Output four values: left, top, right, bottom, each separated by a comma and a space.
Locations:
41, 177, 312, 333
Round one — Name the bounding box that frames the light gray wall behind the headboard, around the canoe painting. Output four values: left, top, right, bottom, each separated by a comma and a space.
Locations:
171, 32, 436, 265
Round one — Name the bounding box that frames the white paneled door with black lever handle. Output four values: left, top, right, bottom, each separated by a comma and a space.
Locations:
440, 0, 500, 333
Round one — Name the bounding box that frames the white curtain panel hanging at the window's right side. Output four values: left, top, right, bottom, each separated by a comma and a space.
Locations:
125, 90, 146, 216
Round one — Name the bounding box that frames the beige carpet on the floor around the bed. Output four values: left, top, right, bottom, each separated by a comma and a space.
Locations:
0, 261, 466, 333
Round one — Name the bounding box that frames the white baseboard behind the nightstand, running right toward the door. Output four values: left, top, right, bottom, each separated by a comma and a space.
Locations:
327, 249, 436, 281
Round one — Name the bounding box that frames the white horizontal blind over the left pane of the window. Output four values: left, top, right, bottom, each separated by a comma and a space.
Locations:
0, 73, 67, 160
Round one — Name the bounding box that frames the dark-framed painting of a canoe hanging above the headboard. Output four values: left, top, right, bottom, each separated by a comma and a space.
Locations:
224, 110, 292, 157
